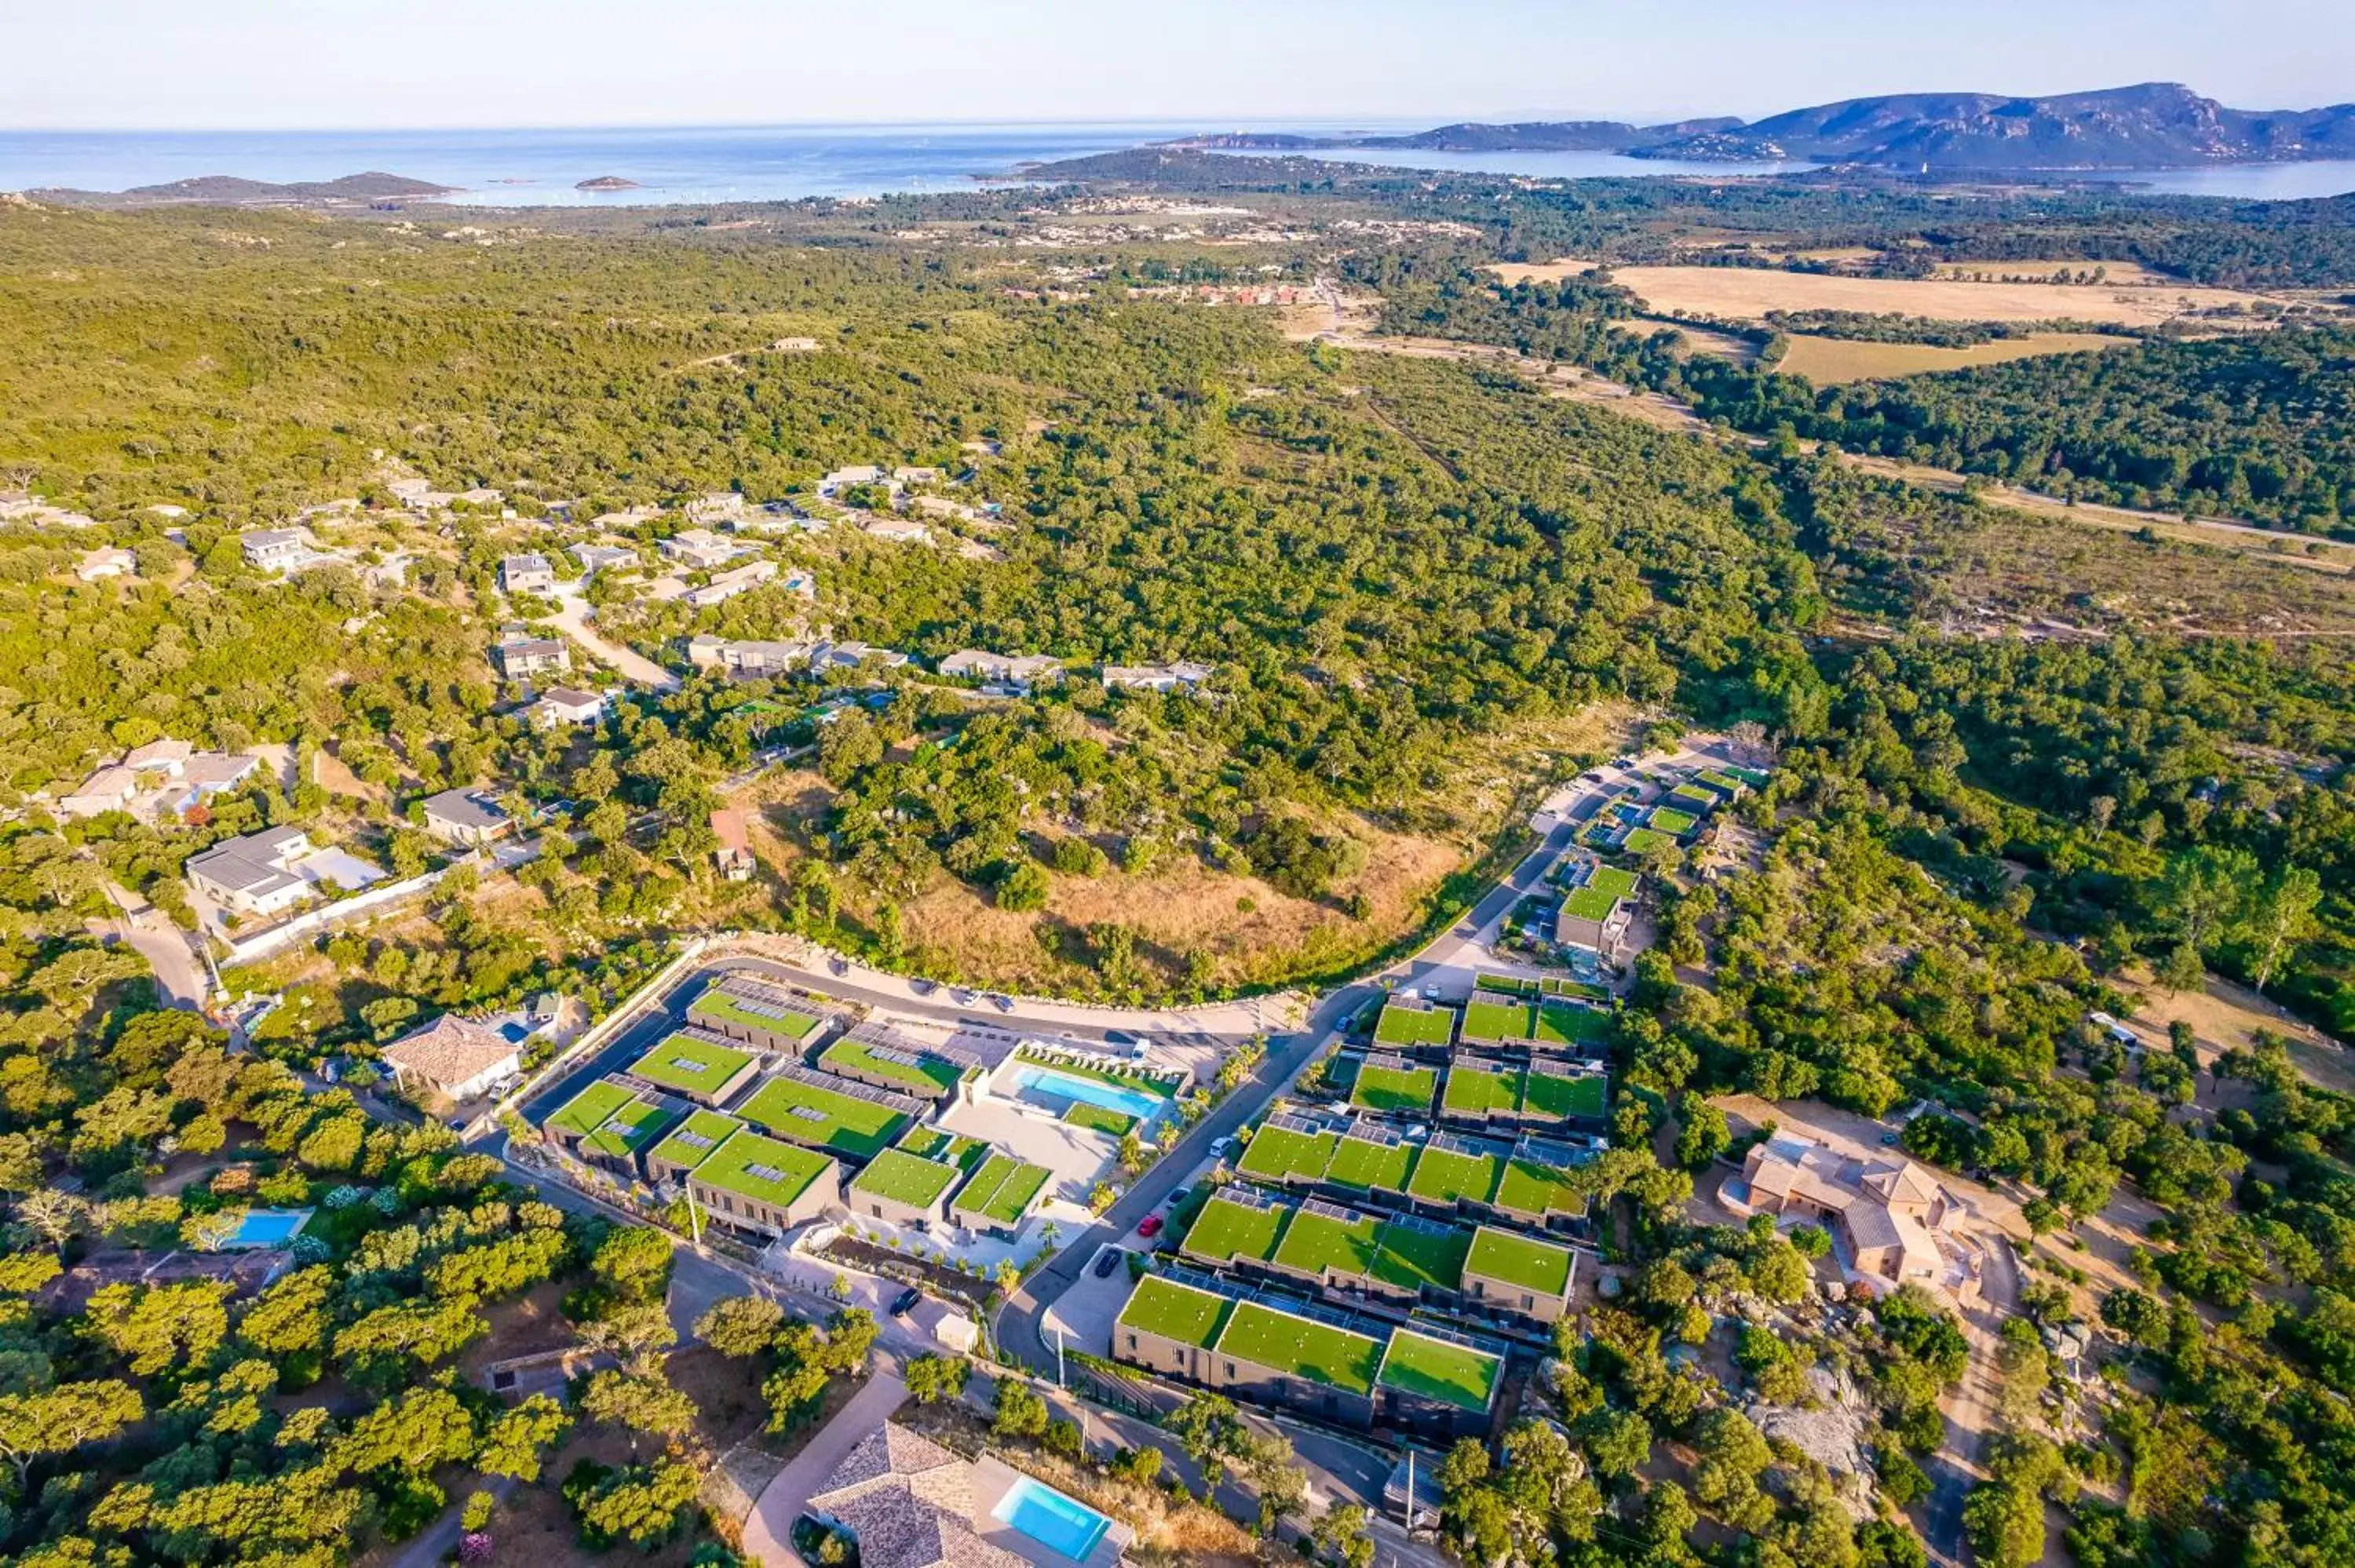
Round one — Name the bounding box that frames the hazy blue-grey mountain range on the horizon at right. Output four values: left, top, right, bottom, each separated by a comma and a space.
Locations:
1173, 82, 2355, 174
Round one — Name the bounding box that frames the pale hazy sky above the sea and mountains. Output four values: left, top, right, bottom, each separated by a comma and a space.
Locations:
18, 0, 2355, 127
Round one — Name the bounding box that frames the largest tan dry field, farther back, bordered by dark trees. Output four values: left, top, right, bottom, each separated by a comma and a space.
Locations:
1613, 266, 2287, 327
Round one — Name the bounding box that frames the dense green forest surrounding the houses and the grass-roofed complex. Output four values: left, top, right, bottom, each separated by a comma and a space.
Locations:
0, 181, 2355, 1568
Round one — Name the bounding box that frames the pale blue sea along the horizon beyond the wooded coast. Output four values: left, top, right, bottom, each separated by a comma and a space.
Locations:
0, 120, 2355, 207
